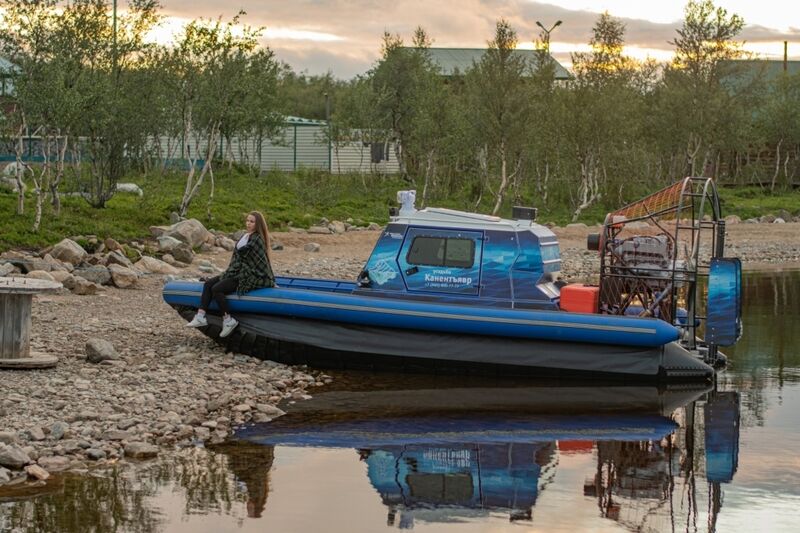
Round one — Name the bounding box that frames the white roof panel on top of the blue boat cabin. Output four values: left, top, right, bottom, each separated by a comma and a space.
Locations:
391, 207, 555, 237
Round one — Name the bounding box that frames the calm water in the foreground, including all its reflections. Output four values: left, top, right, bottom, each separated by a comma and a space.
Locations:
0, 272, 800, 533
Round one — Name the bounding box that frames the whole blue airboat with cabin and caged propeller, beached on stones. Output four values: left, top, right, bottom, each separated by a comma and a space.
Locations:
163, 177, 742, 381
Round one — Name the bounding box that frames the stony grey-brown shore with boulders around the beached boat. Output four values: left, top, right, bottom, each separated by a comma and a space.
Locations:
0, 216, 800, 490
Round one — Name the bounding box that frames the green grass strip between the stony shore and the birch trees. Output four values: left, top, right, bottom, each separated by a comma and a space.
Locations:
0, 169, 800, 251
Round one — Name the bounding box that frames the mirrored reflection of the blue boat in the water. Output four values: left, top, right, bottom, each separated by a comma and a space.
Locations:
237, 378, 739, 530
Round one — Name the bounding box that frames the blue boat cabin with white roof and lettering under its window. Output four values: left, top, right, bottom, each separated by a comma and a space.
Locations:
356, 191, 561, 309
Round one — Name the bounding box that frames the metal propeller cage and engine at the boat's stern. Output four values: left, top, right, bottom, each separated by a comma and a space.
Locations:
599, 177, 725, 362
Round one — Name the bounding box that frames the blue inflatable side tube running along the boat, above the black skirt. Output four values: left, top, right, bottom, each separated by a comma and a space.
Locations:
164, 278, 679, 347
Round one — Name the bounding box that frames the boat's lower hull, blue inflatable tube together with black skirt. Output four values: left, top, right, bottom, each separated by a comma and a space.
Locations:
164, 279, 713, 381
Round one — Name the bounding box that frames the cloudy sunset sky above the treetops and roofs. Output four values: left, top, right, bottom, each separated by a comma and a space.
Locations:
152, 0, 800, 79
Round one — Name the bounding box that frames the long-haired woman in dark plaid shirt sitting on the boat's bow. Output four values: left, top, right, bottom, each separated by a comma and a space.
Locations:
187, 211, 275, 337
